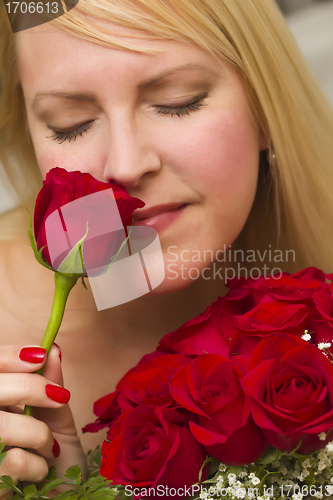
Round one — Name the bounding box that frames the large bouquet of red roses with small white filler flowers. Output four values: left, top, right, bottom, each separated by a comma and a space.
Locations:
84, 268, 333, 500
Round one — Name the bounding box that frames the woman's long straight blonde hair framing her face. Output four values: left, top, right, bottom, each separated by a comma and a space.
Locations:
0, 0, 333, 272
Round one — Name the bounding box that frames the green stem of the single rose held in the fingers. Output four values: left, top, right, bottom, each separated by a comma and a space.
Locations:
24, 272, 77, 416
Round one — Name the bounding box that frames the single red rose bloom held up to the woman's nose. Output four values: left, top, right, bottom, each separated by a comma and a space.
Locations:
34, 167, 144, 270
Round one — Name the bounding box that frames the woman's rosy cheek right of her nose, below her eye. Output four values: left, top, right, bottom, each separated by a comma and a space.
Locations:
175, 107, 259, 199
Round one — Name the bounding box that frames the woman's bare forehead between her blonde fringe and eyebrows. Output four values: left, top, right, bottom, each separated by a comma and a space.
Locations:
16, 23, 231, 89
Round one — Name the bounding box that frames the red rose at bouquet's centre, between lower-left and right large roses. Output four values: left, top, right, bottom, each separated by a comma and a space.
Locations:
170, 354, 267, 465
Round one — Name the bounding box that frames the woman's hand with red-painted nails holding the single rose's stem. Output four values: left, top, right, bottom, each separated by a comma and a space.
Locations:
0, 345, 86, 500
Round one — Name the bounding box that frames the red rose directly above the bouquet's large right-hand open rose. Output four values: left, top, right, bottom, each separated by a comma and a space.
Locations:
230, 300, 308, 356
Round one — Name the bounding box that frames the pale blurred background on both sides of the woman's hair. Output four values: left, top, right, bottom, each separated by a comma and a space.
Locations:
0, 0, 333, 212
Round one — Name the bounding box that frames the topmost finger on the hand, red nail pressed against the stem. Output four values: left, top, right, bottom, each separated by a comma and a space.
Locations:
0, 345, 46, 373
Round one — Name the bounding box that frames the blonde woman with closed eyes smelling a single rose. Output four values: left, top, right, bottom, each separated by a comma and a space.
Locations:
0, 0, 333, 498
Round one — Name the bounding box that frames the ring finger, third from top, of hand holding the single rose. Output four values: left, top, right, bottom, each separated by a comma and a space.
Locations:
0, 411, 56, 458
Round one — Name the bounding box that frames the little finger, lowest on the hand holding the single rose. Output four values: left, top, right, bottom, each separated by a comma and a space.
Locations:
0, 448, 49, 484
